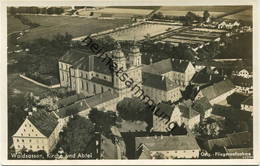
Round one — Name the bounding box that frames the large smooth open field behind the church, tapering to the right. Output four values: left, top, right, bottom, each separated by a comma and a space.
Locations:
19, 15, 130, 41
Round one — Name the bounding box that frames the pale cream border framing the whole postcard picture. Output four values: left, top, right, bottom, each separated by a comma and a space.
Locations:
0, 0, 260, 165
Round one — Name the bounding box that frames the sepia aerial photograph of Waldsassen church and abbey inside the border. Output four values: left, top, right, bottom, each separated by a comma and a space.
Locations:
6, 5, 253, 160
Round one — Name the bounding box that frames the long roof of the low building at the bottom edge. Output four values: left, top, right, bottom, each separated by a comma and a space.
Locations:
135, 135, 200, 151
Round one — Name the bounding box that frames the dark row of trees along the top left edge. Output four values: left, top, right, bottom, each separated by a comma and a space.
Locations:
7, 7, 64, 15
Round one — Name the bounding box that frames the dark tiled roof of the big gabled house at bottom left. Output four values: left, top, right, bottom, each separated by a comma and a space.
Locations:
27, 110, 58, 137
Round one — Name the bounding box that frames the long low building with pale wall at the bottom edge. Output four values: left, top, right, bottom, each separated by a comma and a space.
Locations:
135, 135, 200, 159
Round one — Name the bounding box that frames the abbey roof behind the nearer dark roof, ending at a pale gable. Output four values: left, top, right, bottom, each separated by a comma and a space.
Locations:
143, 58, 190, 74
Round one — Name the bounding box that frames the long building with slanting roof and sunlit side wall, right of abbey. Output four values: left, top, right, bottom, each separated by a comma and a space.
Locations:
195, 79, 235, 105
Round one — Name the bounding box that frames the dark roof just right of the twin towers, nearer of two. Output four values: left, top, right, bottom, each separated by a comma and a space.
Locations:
142, 72, 178, 91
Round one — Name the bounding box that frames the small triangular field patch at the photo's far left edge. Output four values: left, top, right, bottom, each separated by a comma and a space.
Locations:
7, 15, 29, 34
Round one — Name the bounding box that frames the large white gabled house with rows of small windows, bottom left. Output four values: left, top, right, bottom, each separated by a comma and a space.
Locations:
12, 110, 60, 154
